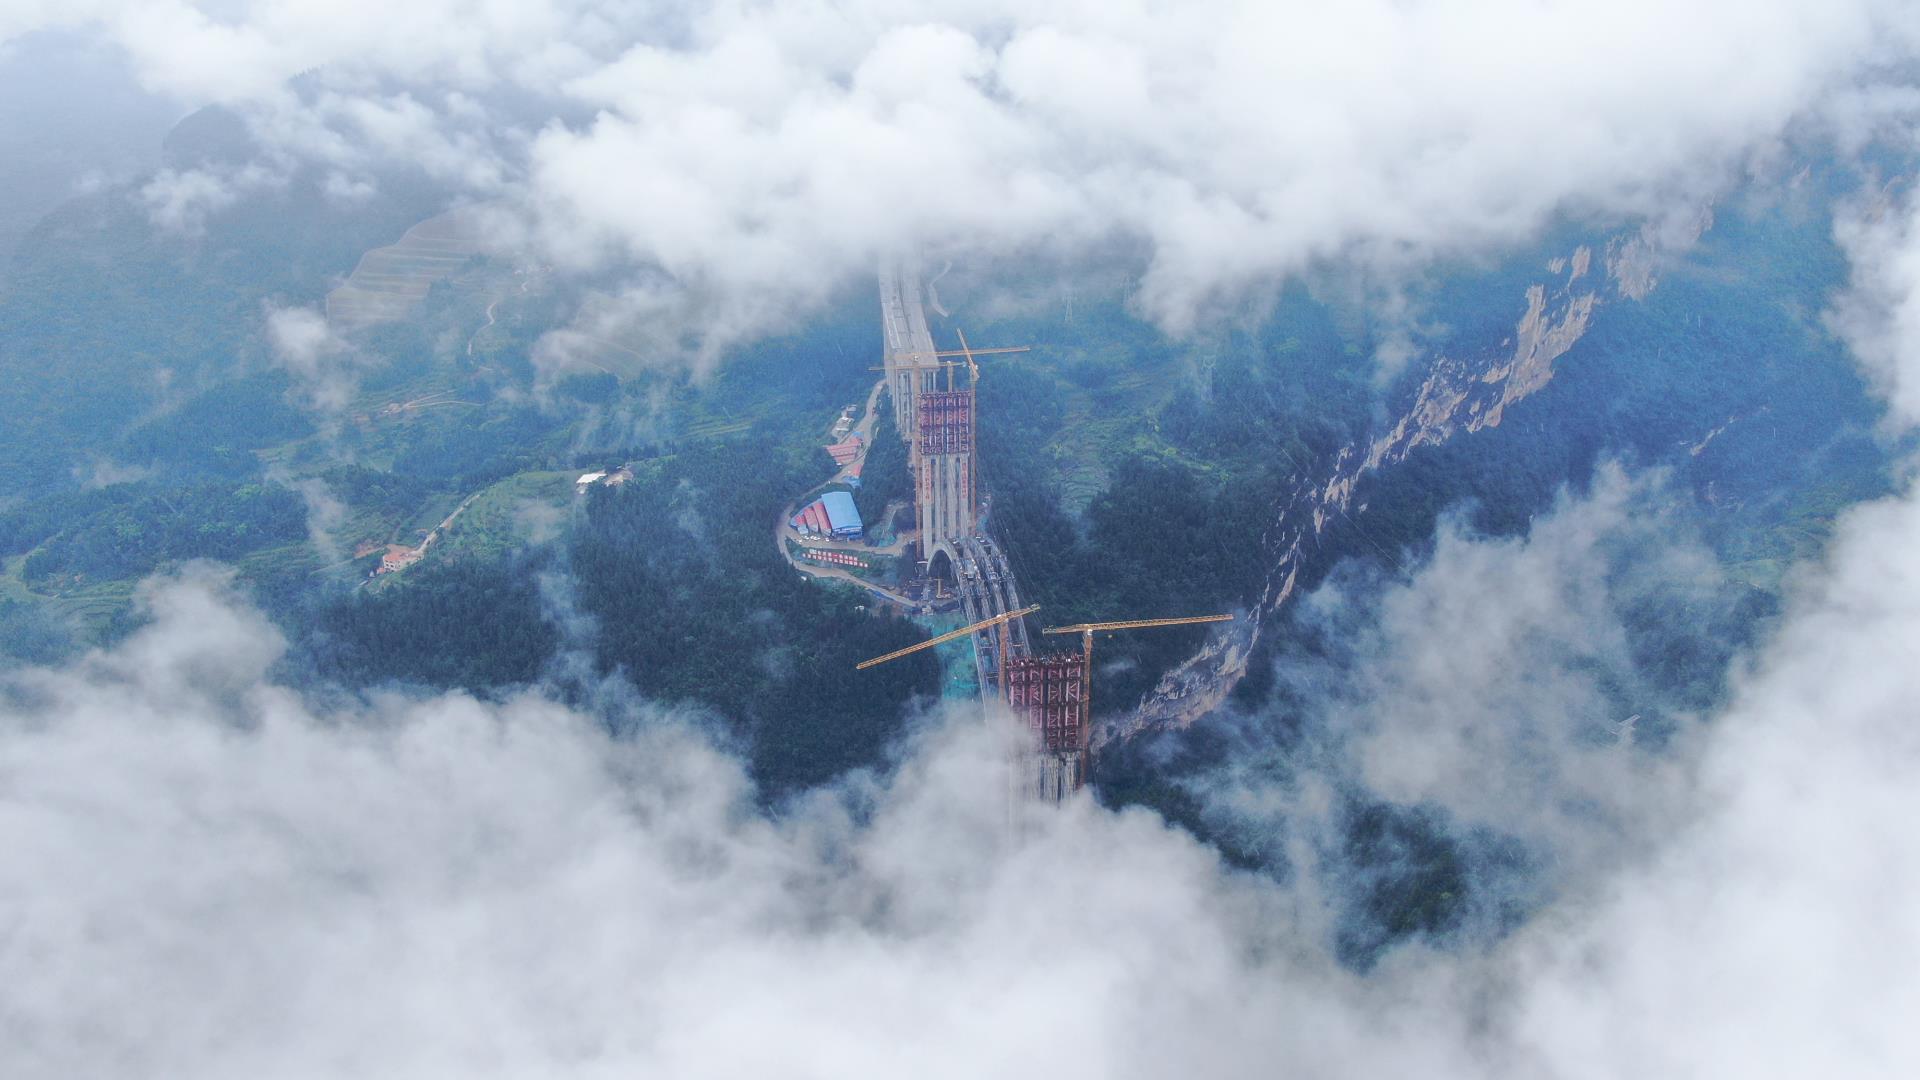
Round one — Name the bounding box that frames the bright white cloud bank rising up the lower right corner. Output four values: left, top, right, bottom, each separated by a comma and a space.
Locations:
1497, 478, 1920, 1076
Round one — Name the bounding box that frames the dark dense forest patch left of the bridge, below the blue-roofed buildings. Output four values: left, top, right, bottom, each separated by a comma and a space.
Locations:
570, 434, 937, 794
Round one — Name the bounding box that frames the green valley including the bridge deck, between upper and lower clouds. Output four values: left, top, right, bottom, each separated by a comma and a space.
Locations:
0, 148, 1884, 814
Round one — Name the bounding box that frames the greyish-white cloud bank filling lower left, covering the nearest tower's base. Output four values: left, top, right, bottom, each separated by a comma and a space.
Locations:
0, 575, 1436, 1076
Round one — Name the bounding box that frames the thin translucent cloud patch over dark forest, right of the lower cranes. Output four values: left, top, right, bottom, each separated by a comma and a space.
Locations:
1304, 467, 1720, 869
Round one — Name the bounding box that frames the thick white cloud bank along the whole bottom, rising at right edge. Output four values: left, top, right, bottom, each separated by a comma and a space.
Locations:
11, 434, 1920, 1076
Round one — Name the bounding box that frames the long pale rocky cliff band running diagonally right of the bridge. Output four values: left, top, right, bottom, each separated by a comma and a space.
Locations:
1094, 231, 1651, 748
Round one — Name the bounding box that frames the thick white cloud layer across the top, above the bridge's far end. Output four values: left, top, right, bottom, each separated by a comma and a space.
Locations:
15, 0, 1920, 349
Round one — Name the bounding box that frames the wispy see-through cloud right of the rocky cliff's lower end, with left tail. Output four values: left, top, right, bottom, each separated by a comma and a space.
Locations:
1221, 465, 1734, 892
